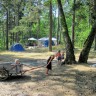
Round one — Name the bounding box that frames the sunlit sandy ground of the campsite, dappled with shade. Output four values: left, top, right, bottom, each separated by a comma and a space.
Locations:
0, 52, 96, 96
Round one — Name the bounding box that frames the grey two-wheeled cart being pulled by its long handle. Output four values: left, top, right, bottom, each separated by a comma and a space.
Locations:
0, 62, 23, 80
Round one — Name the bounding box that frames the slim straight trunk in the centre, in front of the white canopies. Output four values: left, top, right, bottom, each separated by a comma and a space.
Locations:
49, 0, 52, 51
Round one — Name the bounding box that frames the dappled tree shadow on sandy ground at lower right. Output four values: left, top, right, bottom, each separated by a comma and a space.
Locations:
44, 65, 96, 96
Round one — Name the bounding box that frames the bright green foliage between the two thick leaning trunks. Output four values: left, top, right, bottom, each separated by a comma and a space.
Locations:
62, 1, 90, 47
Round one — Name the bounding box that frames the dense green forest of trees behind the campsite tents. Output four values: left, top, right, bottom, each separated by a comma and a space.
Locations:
0, 0, 96, 63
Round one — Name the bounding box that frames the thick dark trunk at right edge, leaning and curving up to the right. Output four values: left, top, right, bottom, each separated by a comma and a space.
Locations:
78, 0, 96, 63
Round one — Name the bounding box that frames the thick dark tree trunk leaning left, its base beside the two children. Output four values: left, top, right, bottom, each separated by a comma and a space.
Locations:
57, 0, 76, 64
